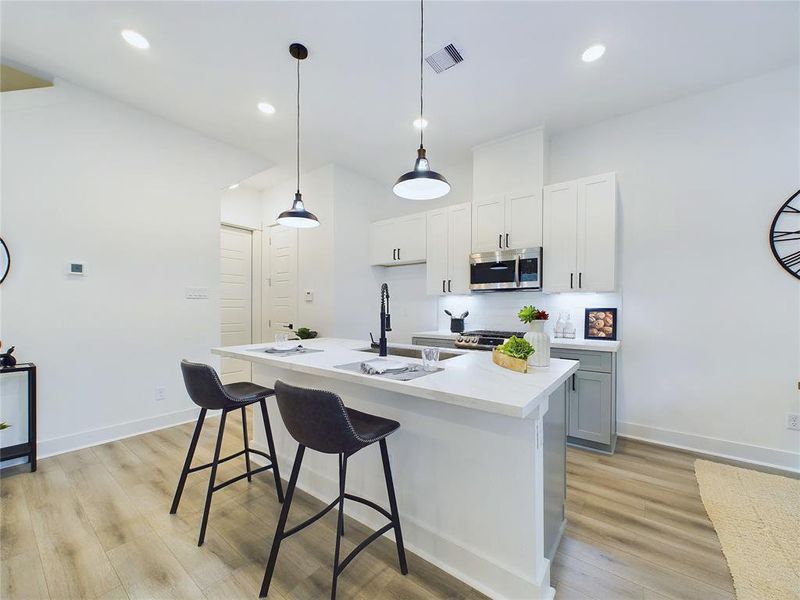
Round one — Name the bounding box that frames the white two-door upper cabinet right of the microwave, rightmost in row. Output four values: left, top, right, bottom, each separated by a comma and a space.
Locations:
542, 173, 617, 292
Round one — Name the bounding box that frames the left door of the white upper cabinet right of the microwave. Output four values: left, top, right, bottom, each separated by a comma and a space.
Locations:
542, 181, 578, 292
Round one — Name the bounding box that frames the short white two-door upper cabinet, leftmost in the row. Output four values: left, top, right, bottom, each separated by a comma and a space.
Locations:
369, 213, 426, 267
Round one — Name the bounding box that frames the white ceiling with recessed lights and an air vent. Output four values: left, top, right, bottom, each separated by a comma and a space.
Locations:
0, 1, 799, 186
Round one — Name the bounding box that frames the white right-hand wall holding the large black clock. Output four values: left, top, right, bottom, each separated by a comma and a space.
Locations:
550, 67, 800, 469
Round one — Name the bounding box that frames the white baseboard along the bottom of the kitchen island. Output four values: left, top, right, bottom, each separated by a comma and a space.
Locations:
250, 440, 555, 600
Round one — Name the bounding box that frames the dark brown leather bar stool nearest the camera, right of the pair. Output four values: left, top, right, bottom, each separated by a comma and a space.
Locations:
259, 381, 408, 600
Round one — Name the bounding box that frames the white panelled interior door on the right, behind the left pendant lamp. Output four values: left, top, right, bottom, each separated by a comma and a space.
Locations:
262, 225, 297, 342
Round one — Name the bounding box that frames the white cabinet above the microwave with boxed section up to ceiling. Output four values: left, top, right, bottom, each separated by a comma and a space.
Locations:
472, 128, 546, 252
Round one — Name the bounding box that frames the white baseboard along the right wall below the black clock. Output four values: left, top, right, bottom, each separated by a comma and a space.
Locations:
617, 421, 800, 473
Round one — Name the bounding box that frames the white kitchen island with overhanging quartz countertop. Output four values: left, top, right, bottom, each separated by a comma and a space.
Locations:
212, 338, 578, 600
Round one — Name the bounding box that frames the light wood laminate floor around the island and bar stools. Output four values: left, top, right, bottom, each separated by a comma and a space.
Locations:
0, 413, 734, 600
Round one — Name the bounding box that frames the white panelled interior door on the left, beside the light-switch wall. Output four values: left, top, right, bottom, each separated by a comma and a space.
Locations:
220, 226, 253, 383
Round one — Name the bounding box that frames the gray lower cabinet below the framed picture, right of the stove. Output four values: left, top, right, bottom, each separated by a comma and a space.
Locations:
552, 348, 617, 453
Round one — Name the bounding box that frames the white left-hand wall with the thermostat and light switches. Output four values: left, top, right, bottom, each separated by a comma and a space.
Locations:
0, 81, 261, 454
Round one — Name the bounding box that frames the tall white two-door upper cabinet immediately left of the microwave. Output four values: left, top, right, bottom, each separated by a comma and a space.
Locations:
426, 203, 472, 296
